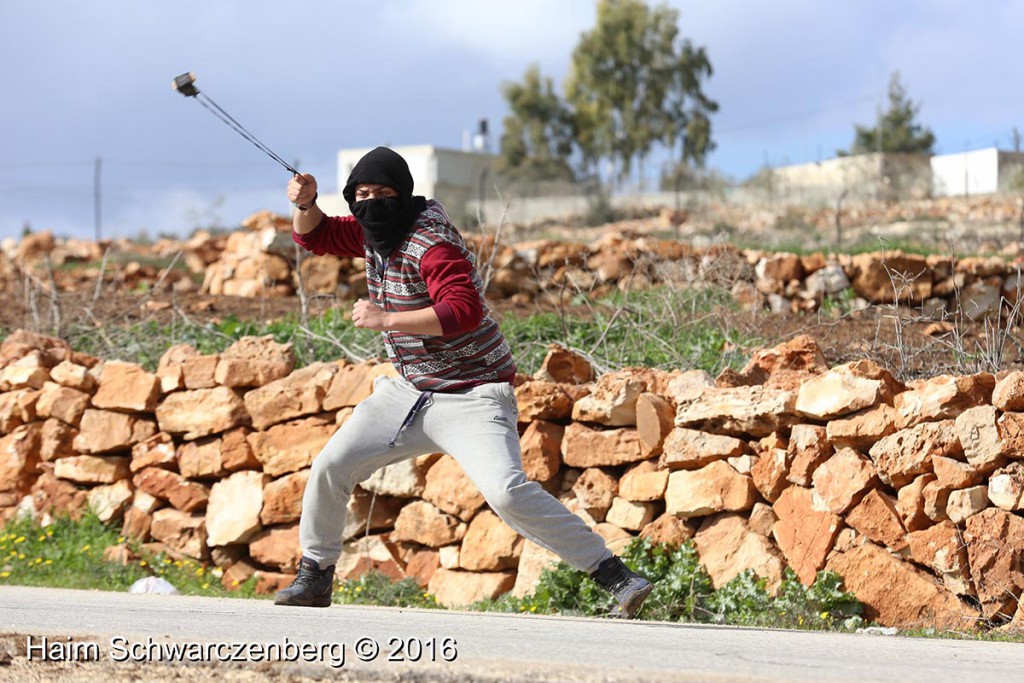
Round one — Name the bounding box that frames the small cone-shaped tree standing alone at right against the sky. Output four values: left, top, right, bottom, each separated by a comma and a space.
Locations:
839, 72, 935, 156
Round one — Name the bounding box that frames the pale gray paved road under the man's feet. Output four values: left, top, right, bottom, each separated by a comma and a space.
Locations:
0, 587, 1024, 683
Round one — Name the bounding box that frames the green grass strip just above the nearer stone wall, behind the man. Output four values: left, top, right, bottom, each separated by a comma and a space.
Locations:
56, 287, 760, 374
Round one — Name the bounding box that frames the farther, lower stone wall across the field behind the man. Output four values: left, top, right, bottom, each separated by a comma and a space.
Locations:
193, 216, 1024, 319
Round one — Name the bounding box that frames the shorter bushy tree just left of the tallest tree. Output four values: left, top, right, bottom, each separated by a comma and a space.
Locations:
500, 65, 573, 180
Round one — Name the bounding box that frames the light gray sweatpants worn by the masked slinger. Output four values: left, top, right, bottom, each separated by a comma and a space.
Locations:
299, 378, 611, 572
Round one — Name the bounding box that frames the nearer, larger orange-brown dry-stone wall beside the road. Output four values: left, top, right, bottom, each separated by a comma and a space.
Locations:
0, 331, 1024, 629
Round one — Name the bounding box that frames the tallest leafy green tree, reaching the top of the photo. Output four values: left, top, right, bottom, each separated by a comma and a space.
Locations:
565, 0, 718, 185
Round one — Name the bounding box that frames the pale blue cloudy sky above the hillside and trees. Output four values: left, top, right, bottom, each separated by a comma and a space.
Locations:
0, 0, 1024, 238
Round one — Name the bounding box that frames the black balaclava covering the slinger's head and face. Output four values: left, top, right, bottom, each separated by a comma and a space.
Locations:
341, 147, 426, 256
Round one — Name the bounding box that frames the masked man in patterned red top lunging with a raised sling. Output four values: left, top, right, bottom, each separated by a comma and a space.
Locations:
274, 147, 652, 617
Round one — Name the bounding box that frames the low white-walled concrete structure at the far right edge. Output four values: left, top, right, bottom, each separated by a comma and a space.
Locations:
932, 147, 1024, 197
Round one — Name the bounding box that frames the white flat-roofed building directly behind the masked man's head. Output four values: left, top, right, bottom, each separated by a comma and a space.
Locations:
317, 144, 498, 226
